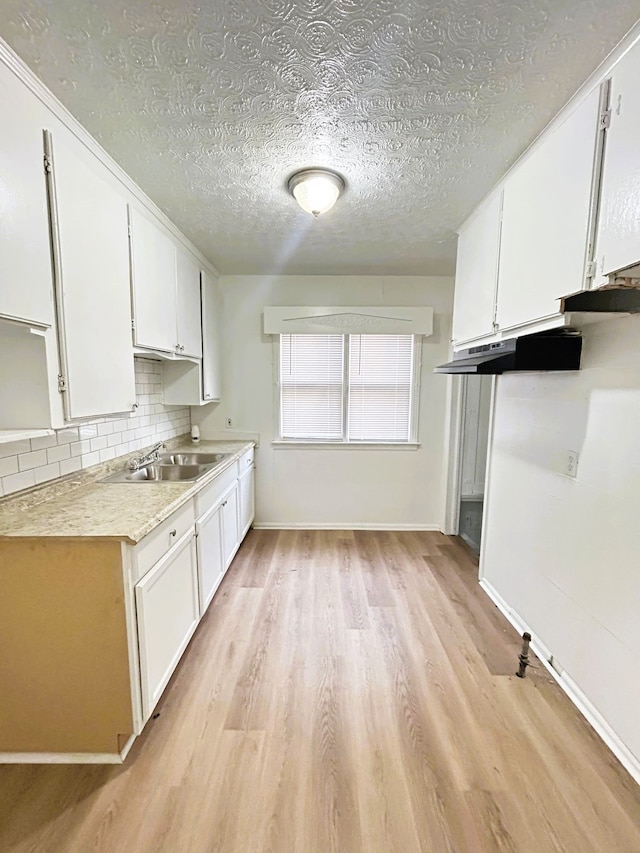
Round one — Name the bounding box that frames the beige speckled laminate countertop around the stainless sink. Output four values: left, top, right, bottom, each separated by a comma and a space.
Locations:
0, 439, 254, 544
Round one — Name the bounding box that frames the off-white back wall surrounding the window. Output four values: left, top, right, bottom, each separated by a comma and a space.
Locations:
192, 276, 453, 529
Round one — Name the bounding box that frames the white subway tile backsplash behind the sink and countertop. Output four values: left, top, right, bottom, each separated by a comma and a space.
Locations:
0, 358, 191, 496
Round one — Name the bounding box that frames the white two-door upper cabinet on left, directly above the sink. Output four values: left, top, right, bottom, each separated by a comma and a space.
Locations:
129, 207, 202, 358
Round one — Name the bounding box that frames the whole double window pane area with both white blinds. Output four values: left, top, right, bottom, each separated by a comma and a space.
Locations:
280, 335, 417, 443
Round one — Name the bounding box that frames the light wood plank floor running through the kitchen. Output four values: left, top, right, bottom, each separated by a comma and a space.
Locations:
0, 531, 640, 853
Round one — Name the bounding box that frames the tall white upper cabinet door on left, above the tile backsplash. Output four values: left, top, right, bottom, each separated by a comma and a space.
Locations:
52, 135, 136, 418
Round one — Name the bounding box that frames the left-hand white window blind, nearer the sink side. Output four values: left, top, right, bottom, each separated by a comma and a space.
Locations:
280, 335, 344, 441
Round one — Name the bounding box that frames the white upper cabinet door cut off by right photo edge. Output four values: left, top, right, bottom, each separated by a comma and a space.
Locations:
595, 44, 640, 285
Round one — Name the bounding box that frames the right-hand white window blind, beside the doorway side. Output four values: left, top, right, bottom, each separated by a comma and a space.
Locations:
347, 335, 413, 441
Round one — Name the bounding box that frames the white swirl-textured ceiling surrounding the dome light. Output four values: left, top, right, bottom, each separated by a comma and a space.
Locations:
0, 0, 640, 274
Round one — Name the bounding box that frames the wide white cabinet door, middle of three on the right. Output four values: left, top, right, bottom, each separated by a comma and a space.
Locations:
496, 89, 600, 329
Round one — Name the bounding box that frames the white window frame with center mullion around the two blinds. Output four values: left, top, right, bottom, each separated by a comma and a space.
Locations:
271, 332, 423, 450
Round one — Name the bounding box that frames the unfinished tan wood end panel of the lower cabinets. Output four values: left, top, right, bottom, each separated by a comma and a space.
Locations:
0, 539, 134, 755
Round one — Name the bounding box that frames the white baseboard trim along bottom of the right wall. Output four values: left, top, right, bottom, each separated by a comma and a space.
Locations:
480, 578, 640, 785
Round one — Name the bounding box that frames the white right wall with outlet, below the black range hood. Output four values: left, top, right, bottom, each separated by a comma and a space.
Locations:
482, 317, 640, 778
